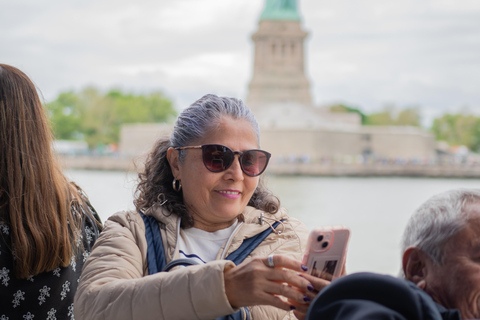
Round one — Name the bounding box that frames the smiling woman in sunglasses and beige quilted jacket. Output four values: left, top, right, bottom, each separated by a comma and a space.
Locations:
75, 95, 327, 320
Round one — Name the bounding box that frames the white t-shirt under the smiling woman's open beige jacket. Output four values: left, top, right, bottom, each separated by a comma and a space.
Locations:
178, 220, 238, 264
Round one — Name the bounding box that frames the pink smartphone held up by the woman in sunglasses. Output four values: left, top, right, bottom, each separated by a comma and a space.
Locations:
303, 226, 350, 280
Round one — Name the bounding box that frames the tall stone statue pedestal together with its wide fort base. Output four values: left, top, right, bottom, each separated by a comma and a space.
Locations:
119, 0, 435, 166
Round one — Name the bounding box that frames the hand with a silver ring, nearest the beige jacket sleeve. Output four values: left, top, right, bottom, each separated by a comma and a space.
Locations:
224, 255, 315, 311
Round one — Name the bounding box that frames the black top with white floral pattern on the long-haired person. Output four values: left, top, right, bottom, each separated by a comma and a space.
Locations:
0, 199, 100, 320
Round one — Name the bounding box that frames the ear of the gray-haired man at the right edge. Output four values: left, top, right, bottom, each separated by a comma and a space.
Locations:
402, 247, 430, 286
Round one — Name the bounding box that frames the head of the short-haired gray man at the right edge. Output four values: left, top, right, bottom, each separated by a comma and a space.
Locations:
402, 189, 480, 319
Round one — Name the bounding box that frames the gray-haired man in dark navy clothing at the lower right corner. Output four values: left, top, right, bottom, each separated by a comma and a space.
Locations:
307, 189, 480, 320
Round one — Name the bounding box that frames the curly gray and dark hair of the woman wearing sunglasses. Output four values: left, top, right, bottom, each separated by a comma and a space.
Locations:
134, 94, 280, 228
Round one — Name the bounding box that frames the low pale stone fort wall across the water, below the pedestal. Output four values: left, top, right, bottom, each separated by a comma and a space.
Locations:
119, 124, 435, 162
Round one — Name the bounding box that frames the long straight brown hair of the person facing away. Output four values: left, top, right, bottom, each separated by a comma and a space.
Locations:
0, 64, 97, 278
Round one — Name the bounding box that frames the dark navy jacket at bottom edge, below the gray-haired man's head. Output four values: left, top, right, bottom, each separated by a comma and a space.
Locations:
307, 273, 461, 320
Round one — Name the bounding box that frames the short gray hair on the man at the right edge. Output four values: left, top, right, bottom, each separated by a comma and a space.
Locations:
402, 189, 480, 264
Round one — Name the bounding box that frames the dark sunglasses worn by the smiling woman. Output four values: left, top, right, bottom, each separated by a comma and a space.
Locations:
174, 144, 272, 177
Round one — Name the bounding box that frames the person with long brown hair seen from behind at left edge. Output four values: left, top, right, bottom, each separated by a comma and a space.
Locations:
0, 64, 101, 320
